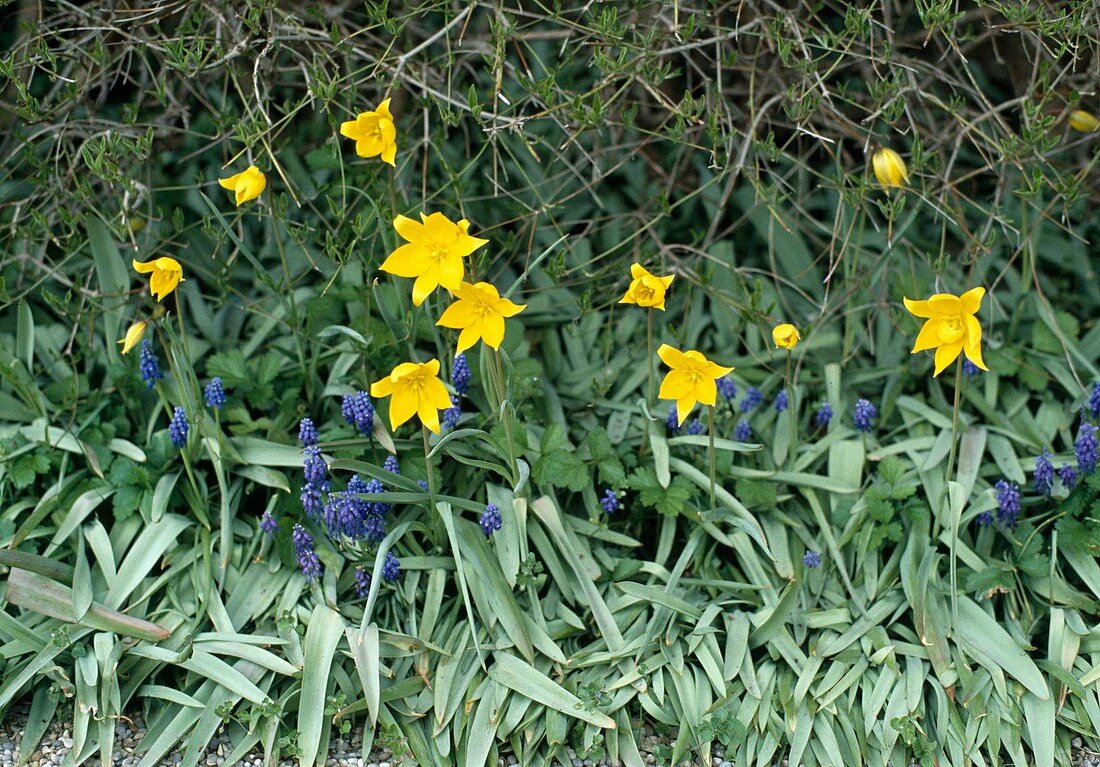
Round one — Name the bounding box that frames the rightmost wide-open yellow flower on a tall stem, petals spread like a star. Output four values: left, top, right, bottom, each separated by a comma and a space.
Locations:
904, 287, 989, 375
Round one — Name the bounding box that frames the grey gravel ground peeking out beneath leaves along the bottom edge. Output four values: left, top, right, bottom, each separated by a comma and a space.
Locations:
0, 706, 1100, 767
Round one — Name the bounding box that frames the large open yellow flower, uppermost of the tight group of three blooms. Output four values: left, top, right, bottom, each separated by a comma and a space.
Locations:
382, 213, 488, 306
